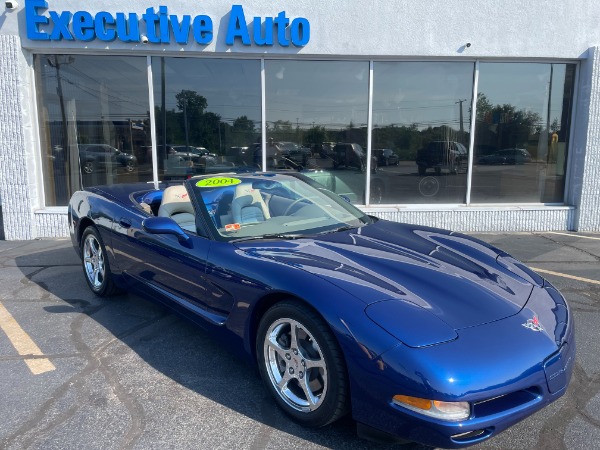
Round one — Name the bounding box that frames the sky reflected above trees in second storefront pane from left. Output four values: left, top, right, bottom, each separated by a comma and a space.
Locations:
152, 58, 261, 124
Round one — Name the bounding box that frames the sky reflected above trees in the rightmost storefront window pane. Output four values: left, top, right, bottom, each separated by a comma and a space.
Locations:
479, 63, 566, 125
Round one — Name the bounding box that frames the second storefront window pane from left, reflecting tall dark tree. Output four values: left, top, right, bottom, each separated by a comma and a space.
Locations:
148, 58, 262, 180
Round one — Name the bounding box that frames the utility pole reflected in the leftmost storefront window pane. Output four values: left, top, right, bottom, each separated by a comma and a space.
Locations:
47, 55, 77, 200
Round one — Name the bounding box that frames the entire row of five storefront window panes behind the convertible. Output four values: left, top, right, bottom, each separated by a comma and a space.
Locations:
34, 55, 575, 206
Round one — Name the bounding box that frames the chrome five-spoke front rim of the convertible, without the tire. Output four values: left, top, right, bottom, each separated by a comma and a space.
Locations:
263, 318, 327, 412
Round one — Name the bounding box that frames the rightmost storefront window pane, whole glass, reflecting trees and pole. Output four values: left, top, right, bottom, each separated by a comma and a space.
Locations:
471, 63, 575, 203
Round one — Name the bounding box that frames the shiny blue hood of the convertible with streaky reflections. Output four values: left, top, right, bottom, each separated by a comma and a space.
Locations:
236, 220, 533, 330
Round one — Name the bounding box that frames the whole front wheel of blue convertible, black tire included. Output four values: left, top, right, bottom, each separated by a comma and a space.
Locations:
256, 300, 349, 427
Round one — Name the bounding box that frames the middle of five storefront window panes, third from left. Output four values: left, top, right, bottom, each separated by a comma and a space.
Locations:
265, 60, 368, 204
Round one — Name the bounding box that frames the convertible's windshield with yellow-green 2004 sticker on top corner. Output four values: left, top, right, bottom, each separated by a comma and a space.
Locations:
188, 172, 371, 240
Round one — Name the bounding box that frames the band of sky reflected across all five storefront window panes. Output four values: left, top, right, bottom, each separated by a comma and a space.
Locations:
43, 55, 566, 129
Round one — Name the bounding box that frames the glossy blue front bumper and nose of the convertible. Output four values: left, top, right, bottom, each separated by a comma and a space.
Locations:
351, 285, 575, 448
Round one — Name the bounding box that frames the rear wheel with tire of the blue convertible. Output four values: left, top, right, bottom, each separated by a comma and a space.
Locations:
80, 226, 118, 297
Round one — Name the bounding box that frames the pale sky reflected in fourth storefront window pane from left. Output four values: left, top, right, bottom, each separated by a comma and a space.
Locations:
373, 62, 473, 129
